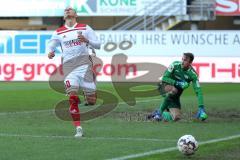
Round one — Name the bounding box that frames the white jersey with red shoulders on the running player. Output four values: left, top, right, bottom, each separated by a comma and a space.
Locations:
48, 23, 101, 63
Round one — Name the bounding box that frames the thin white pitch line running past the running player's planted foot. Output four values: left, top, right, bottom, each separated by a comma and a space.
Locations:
0, 133, 175, 142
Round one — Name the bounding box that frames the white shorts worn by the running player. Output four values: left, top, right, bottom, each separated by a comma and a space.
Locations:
64, 64, 96, 95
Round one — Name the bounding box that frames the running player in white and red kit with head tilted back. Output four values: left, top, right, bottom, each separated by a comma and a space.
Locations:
48, 7, 101, 137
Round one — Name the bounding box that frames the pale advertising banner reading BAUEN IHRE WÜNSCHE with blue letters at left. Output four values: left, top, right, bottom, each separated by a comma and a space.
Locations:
0, 30, 240, 57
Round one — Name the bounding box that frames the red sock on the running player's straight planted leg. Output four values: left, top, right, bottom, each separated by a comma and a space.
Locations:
69, 95, 81, 127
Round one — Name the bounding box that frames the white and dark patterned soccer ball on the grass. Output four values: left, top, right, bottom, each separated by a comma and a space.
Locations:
177, 135, 198, 155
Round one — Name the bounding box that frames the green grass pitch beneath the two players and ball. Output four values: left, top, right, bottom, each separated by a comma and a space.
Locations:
0, 82, 240, 160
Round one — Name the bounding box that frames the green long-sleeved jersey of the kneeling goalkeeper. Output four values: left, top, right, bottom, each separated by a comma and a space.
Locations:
162, 61, 203, 105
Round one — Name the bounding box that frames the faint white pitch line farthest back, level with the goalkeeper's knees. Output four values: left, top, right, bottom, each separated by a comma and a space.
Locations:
0, 98, 160, 116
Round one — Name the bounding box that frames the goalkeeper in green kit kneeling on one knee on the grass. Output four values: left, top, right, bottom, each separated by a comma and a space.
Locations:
147, 53, 207, 121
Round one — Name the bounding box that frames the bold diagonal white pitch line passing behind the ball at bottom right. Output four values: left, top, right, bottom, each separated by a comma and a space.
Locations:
108, 134, 240, 160
